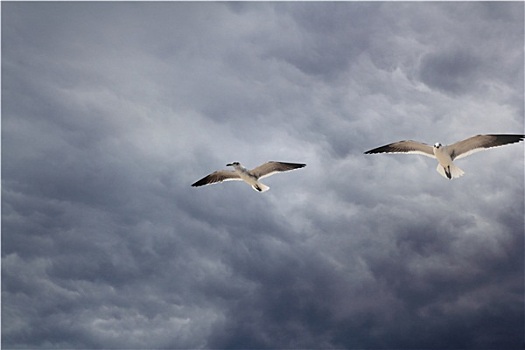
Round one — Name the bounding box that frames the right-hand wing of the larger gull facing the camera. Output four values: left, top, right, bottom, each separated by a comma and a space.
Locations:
447, 134, 524, 160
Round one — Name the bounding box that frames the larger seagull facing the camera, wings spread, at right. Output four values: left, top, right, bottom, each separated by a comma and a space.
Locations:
365, 134, 524, 179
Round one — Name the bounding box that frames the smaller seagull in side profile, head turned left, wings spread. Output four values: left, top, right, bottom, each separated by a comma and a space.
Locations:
192, 161, 306, 192
